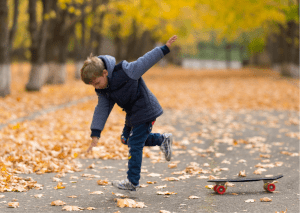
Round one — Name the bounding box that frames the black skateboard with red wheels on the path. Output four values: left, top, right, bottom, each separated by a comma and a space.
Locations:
207, 174, 283, 195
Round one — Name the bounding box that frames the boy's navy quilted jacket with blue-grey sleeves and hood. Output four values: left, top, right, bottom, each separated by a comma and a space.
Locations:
91, 45, 170, 137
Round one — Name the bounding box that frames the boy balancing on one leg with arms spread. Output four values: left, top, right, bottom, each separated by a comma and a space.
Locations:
81, 36, 177, 191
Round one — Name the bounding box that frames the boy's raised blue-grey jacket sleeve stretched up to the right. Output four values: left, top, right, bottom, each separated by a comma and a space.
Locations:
122, 45, 170, 80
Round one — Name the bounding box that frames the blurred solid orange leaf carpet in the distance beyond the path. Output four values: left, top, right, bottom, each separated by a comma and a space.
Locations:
0, 63, 299, 124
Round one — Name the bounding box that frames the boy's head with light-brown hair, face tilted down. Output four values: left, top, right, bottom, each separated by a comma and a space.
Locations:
80, 54, 108, 89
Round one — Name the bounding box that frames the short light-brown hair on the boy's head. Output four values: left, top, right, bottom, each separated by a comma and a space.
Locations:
80, 53, 105, 84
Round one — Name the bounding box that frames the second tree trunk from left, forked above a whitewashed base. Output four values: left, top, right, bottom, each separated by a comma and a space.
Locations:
26, 0, 50, 91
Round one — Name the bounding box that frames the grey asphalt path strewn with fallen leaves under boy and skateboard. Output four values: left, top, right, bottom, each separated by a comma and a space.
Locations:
0, 98, 299, 212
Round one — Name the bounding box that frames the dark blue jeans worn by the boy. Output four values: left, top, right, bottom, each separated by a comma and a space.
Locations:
121, 121, 164, 186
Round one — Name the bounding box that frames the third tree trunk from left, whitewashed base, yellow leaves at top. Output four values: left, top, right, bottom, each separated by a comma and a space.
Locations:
46, 0, 83, 84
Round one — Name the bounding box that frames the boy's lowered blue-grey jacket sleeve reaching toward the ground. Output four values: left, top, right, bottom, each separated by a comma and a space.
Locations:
91, 93, 115, 137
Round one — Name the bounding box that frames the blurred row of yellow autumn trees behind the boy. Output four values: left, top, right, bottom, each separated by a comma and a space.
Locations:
0, 0, 299, 97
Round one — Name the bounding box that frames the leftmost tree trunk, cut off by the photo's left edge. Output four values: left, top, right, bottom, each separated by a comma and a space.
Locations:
0, 0, 11, 97
